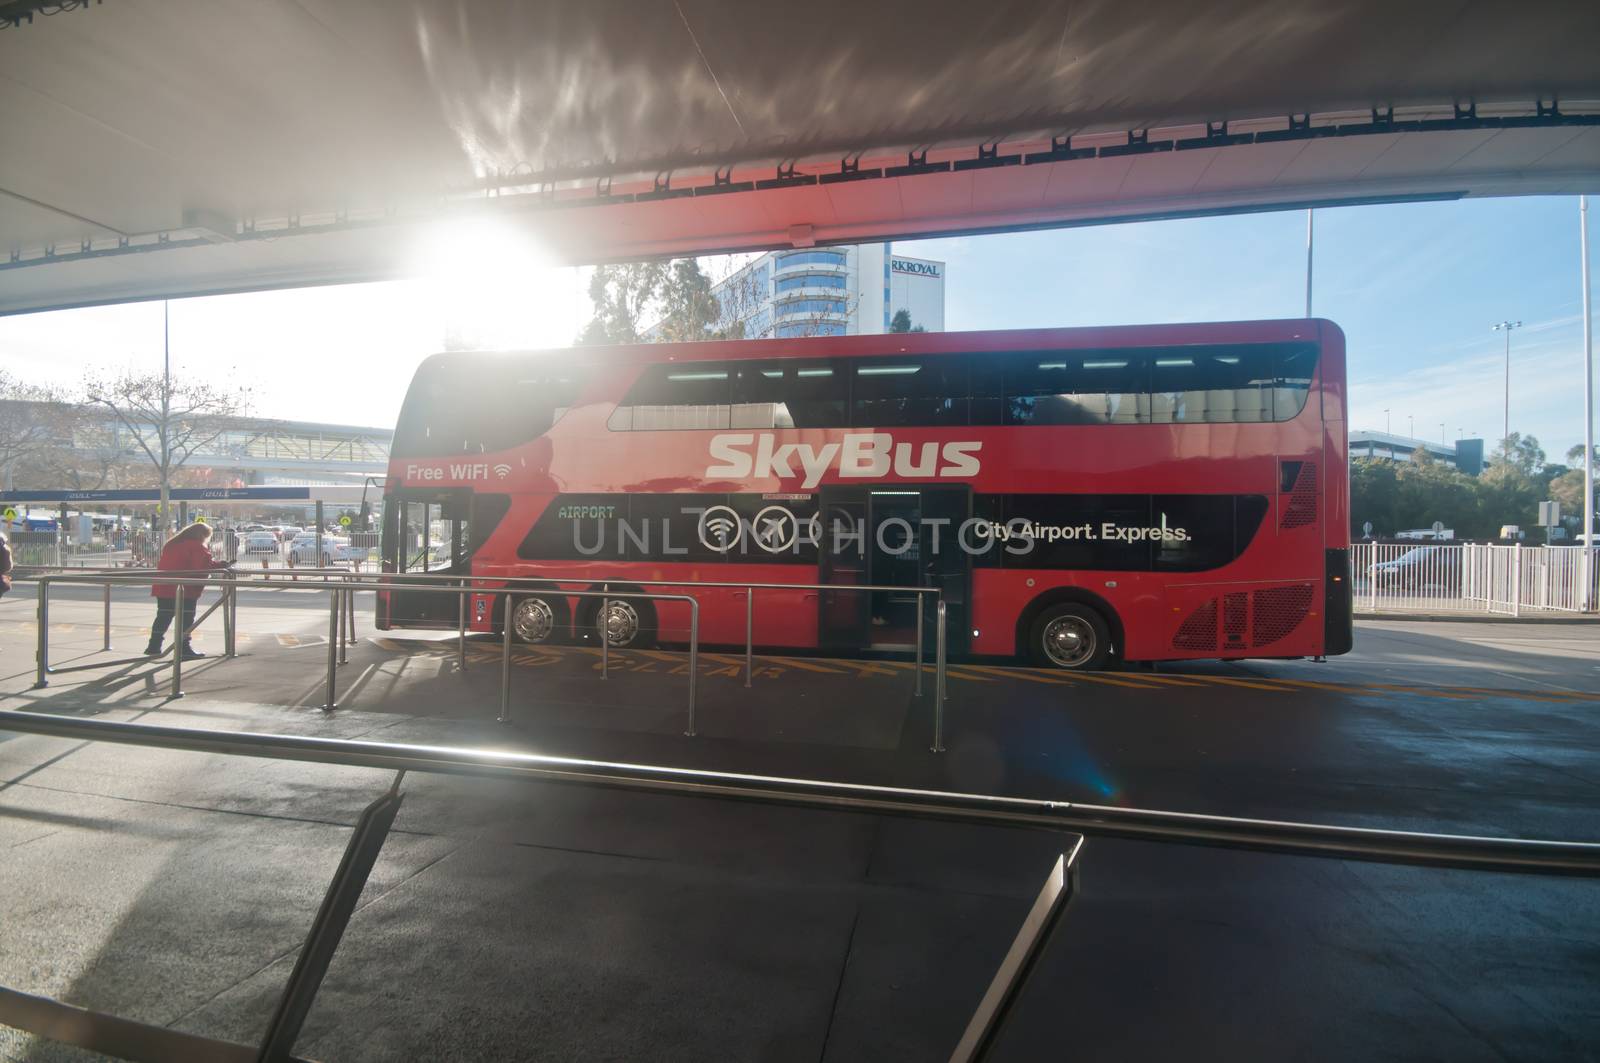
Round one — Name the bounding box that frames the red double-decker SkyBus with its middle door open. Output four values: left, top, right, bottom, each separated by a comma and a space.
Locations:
378, 320, 1350, 669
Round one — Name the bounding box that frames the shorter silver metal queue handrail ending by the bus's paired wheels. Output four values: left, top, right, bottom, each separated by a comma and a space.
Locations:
34, 572, 699, 738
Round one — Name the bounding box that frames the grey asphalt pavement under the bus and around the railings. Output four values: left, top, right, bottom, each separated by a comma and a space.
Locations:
0, 591, 1600, 1060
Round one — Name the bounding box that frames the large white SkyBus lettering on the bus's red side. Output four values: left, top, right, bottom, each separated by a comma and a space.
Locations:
706, 432, 982, 488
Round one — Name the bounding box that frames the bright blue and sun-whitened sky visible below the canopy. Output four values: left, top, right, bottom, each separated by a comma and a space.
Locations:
0, 197, 1600, 461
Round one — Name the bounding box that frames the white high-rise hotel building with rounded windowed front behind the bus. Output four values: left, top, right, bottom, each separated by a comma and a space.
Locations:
712, 243, 944, 339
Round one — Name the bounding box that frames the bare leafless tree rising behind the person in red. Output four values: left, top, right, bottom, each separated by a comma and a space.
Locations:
88, 371, 250, 528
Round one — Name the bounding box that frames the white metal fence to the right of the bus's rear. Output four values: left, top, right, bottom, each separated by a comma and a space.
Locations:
1350, 543, 1600, 616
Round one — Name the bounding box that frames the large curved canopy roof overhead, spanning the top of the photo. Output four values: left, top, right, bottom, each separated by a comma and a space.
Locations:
0, 0, 1600, 312
